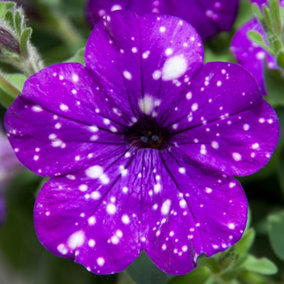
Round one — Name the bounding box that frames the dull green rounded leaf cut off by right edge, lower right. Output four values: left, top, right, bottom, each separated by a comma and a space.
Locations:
268, 211, 284, 260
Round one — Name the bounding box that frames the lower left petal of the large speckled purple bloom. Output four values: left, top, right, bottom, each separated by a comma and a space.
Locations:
34, 146, 143, 274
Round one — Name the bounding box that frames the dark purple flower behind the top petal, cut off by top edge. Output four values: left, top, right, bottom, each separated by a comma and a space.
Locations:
86, 0, 239, 39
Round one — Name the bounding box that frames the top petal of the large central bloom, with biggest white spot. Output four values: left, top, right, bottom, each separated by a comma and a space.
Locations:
85, 12, 203, 118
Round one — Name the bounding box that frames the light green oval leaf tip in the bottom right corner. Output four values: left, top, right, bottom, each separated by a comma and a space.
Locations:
241, 255, 278, 275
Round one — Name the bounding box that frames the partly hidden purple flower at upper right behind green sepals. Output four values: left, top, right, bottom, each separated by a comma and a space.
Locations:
231, 0, 284, 94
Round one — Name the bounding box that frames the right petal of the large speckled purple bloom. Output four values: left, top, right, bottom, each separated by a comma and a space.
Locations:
163, 62, 279, 176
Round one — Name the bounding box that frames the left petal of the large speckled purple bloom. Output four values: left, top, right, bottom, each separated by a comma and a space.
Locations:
5, 64, 124, 175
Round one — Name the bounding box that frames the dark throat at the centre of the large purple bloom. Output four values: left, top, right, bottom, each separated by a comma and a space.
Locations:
125, 117, 170, 150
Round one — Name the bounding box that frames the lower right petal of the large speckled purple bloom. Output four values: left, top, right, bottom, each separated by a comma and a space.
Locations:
145, 150, 247, 274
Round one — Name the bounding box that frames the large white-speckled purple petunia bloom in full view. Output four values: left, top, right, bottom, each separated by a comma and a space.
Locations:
5, 12, 279, 274
